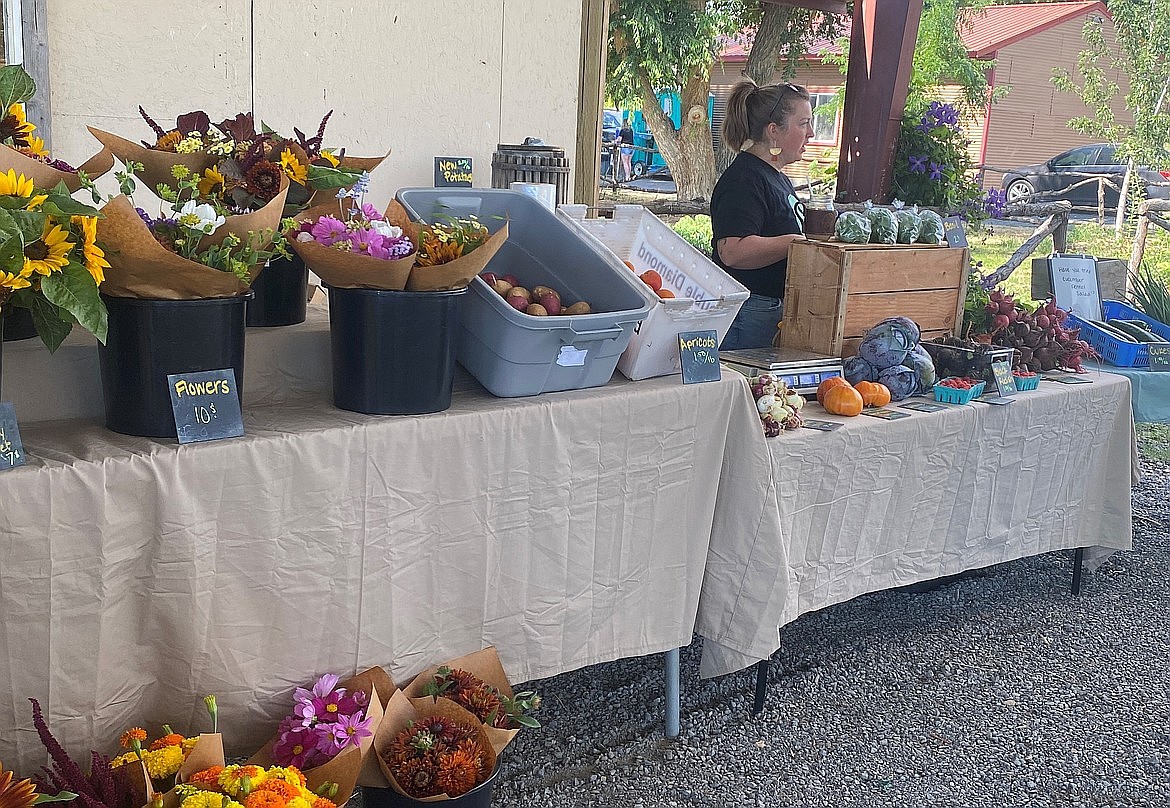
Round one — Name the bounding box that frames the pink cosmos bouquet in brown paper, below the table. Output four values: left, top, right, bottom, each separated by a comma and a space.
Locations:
248, 668, 394, 803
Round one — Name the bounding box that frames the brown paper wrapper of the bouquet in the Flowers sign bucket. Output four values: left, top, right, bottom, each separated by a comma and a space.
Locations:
97, 177, 287, 301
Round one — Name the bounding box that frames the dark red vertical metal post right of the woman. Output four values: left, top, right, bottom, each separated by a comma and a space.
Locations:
837, 0, 922, 202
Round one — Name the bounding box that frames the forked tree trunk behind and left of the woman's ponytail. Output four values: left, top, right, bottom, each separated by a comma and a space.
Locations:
638, 65, 715, 201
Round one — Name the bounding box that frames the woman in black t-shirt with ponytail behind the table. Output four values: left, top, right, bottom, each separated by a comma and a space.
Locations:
711, 81, 813, 351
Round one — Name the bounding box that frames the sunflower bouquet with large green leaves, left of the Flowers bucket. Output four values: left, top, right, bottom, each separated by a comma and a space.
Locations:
0, 168, 110, 351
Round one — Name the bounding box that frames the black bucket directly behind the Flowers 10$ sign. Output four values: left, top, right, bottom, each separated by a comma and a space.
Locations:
97, 295, 248, 440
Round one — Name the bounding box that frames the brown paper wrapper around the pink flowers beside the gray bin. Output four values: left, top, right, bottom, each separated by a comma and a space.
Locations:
284, 200, 418, 291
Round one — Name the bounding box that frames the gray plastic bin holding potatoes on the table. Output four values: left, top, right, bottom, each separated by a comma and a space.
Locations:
397, 188, 651, 396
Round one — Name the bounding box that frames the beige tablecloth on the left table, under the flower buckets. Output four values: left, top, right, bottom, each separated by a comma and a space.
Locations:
0, 312, 768, 773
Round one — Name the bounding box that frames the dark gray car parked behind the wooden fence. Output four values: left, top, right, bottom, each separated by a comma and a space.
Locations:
1002, 143, 1170, 208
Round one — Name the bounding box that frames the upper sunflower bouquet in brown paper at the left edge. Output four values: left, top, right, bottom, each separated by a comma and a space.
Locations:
0, 64, 113, 193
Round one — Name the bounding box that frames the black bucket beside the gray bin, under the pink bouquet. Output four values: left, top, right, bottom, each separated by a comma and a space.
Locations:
326, 286, 467, 415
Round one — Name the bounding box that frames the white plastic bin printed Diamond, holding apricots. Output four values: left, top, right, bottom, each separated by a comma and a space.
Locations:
557, 205, 749, 380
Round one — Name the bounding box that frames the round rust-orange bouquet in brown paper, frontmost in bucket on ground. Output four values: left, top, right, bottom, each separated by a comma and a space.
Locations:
372, 691, 496, 808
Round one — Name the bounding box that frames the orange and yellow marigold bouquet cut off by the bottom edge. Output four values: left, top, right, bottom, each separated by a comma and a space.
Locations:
174, 765, 336, 808
